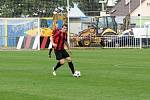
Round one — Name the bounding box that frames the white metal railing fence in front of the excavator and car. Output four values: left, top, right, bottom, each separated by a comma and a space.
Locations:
70, 35, 150, 48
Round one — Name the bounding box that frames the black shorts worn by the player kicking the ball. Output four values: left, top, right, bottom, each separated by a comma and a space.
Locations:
55, 50, 70, 60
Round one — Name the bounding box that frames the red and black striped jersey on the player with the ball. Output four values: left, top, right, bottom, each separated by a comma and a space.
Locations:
53, 30, 67, 50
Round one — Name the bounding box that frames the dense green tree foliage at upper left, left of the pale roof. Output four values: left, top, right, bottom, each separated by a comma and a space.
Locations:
0, 0, 67, 17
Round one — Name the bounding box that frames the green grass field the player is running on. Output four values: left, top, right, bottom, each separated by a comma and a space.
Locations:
0, 49, 150, 100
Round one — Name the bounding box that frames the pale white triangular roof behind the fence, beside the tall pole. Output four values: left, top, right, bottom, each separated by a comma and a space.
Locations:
69, 3, 86, 18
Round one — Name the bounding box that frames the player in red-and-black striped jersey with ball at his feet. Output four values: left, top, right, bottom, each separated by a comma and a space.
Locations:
50, 24, 75, 76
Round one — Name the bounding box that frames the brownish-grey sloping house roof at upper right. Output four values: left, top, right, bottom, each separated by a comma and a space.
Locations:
110, 0, 145, 16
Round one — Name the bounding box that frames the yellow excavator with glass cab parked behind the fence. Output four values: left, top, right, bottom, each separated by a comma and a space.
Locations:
78, 16, 117, 47
